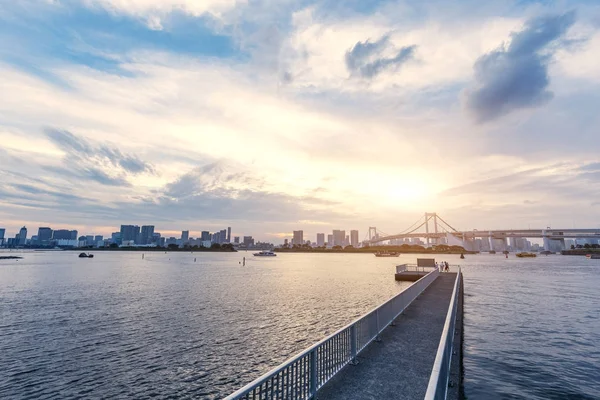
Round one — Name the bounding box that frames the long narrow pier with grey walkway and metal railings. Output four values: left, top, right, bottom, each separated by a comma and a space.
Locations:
225, 264, 463, 400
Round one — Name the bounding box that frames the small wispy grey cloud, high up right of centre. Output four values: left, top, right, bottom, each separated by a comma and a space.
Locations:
346, 35, 417, 79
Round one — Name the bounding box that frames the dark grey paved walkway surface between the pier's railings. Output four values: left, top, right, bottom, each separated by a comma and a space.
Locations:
317, 272, 458, 400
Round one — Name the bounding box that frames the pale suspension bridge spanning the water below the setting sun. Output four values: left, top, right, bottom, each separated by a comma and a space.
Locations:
366, 213, 600, 251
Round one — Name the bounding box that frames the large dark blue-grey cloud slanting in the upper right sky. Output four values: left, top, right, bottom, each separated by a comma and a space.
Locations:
465, 12, 575, 123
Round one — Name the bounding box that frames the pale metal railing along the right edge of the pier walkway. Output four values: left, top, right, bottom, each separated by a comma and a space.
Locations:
425, 267, 461, 400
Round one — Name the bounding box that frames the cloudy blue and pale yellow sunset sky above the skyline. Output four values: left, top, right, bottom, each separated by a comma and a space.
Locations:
0, 0, 600, 243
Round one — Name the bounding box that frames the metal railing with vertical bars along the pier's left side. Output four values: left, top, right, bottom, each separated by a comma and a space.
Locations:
225, 270, 440, 400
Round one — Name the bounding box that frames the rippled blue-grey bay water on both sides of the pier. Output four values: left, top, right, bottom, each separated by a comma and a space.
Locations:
0, 252, 600, 399
